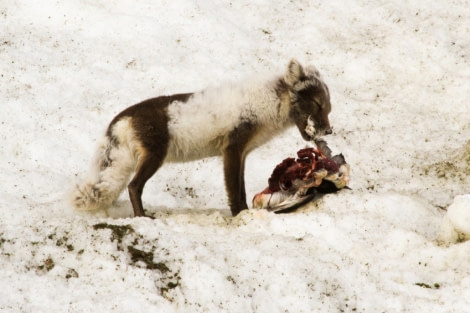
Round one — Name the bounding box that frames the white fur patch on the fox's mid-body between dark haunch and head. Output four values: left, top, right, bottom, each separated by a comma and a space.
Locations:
167, 74, 289, 161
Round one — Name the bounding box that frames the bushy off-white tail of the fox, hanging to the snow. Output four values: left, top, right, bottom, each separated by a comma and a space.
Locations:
70, 130, 135, 211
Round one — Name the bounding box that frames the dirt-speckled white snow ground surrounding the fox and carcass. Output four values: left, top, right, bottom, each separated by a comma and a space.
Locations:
0, 0, 470, 312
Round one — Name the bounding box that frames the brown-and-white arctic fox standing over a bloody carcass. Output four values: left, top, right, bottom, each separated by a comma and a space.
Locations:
71, 59, 331, 216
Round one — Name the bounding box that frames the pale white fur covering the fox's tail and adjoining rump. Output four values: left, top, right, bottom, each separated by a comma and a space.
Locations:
70, 118, 142, 211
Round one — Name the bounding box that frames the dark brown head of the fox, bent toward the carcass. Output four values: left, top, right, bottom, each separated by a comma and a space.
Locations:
284, 59, 332, 140
